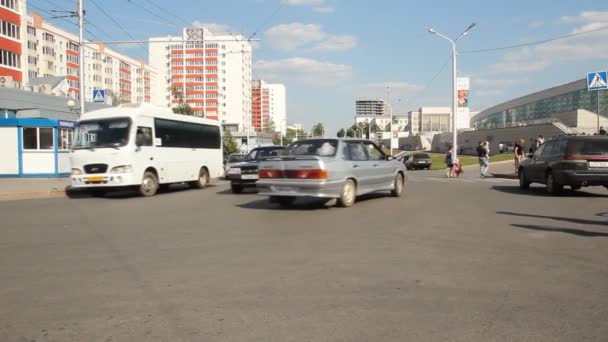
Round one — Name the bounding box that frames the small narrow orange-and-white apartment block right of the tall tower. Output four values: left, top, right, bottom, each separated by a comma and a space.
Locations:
251, 80, 287, 134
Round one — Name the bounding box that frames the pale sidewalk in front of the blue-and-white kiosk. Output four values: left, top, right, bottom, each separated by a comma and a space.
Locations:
0, 177, 70, 201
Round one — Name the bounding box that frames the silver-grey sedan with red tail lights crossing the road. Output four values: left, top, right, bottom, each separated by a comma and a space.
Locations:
257, 139, 407, 207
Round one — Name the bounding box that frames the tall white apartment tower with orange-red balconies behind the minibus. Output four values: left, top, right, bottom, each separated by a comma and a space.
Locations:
149, 27, 251, 131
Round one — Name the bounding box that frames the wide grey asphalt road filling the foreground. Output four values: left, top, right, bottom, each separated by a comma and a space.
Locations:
0, 171, 608, 342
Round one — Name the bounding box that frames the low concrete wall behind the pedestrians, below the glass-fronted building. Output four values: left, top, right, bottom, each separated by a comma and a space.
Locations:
431, 124, 566, 155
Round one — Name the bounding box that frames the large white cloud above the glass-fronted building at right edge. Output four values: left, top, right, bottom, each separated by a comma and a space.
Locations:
489, 11, 608, 73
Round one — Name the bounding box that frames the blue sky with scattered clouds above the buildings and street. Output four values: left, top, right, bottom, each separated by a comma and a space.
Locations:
28, 0, 608, 131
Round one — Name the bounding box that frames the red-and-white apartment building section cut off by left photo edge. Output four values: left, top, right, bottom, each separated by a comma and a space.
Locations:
0, 0, 27, 87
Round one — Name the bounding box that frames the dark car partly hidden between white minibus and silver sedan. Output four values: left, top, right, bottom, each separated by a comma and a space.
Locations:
226, 146, 283, 194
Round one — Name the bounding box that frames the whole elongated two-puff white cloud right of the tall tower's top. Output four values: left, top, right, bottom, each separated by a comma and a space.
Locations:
264, 23, 358, 51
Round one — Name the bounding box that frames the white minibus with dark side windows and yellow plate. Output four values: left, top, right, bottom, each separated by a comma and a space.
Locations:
70, 104, 223, 196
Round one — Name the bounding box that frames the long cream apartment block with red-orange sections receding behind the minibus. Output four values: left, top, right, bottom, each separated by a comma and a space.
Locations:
0, 0, 156, 103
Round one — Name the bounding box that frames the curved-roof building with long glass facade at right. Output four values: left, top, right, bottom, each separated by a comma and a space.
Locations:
471, 79, 608, 129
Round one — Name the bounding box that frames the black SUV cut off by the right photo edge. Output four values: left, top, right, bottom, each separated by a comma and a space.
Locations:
518, 136, 608, 194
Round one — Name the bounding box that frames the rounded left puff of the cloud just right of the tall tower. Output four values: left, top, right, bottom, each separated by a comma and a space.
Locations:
264, 23, 326, 51
